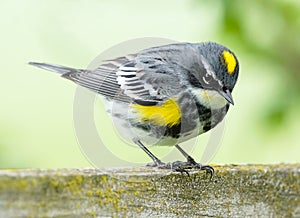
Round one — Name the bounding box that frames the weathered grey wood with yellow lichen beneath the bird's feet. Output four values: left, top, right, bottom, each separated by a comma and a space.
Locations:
0, 164, 300, 217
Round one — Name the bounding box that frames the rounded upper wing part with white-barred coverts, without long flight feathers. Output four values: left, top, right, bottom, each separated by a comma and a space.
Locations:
116, 54, 183, 104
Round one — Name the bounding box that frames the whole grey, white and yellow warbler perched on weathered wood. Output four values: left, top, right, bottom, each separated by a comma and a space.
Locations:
29, 42, 239, 176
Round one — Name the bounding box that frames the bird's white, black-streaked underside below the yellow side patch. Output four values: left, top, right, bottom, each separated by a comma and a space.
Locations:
105, 98, 228, 146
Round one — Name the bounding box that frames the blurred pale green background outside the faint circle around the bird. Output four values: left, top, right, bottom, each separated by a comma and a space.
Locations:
0, 0, 300, 168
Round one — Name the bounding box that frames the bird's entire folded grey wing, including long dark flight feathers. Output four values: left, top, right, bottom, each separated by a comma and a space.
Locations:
62, 48, 191, 105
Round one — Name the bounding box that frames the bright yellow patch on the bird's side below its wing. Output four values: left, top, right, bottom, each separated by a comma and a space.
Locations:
131, 99, 181, 127
